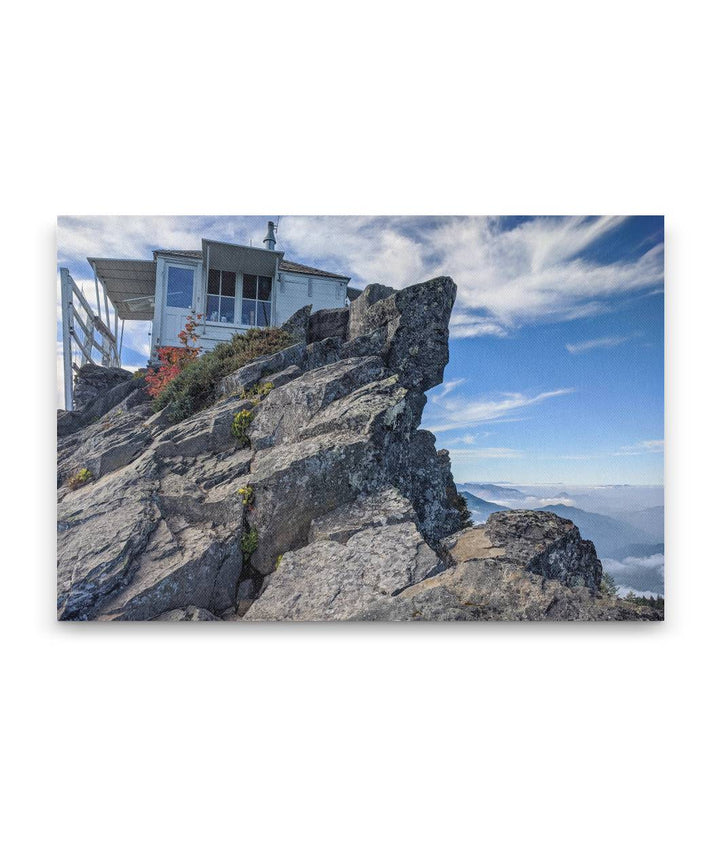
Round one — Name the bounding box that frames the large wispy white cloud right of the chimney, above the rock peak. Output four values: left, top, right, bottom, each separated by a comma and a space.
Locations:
281, 217, 663, 338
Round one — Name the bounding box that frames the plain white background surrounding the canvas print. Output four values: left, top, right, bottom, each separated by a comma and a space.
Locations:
0, 0, 720, 856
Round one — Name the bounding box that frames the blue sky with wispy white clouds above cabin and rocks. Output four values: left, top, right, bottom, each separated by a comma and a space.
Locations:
58, 214, 664, 484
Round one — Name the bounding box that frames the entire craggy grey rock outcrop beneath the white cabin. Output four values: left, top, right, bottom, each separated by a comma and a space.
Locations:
58, 277, 664, 621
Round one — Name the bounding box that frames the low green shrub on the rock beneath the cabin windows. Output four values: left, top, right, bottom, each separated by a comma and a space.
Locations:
153, 327, 293, 422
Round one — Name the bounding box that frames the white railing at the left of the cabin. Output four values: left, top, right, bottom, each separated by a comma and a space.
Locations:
60, 268, 120, 410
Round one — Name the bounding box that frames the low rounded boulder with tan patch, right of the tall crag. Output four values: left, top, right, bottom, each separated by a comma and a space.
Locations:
353, 511, 660, 621
